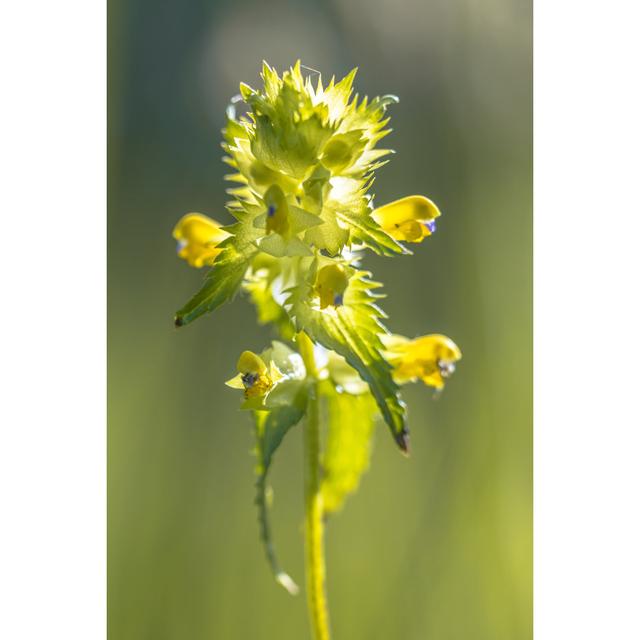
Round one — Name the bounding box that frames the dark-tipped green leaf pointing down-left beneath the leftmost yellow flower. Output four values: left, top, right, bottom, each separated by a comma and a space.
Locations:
175, 238, 255, 327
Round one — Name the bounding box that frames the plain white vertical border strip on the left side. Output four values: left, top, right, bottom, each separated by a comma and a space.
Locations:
0, 0, 106, 640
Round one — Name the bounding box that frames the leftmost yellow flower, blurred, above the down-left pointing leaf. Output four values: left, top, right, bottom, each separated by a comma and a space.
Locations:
173, 213, 230, 269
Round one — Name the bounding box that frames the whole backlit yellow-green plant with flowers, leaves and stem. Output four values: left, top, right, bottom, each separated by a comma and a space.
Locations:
174, 63, 461, 640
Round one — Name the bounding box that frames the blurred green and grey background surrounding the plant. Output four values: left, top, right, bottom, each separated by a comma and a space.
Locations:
108, 0, 532, 640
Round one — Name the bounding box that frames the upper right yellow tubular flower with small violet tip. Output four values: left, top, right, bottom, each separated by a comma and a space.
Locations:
371, 196, 440, 242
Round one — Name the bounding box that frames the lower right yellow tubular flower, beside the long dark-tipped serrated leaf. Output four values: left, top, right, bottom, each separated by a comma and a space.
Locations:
383, 334, 462, 389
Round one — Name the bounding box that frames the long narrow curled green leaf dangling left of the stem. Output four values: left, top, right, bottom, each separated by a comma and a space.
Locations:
253, 406, 304, 595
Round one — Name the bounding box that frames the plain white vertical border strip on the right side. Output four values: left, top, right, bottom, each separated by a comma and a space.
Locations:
534, 0, 640, 640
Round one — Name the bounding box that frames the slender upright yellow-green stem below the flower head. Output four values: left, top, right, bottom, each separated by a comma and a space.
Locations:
297, 331, 331, 640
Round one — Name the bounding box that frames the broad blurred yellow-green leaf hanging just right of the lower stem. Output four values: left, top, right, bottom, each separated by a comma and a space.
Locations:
320, 381, 379, 513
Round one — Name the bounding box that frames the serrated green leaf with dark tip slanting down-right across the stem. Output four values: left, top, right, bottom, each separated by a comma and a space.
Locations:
285, 269, 409, 453
